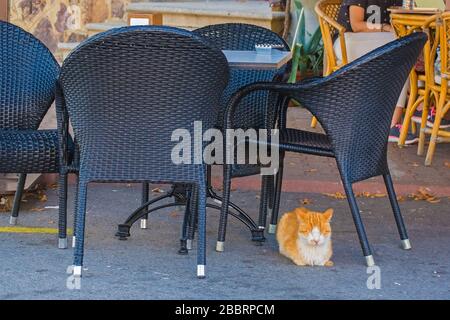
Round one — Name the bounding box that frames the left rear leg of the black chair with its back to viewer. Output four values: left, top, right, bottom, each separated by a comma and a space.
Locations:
73, 180, 88, 277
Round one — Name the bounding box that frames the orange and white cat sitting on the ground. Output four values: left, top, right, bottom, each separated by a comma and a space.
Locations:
277, 208, 333, 267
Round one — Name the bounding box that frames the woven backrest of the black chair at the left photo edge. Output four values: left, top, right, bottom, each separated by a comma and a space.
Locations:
0, 21, 59, 129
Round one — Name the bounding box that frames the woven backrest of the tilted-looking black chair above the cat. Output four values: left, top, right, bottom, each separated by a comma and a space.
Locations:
292, 32, 427, 183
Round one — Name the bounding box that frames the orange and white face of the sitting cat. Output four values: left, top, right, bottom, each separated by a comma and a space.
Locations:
295, 208, 333, 247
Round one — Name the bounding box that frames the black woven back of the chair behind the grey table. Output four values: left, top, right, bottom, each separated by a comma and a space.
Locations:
194, 23, 289, 129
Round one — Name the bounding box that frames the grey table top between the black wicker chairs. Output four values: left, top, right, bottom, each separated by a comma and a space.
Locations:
223, 49, 292, 70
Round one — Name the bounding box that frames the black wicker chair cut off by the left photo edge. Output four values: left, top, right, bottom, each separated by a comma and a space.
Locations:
0, 21, 70, 248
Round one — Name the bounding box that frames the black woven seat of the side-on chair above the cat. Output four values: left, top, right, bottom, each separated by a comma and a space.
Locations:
280, 128, 334, 157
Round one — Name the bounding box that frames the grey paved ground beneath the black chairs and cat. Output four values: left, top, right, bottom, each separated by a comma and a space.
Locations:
0, 185, 450, 299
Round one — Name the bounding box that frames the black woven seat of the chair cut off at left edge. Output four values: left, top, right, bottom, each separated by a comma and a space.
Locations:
0, 130, 59, 173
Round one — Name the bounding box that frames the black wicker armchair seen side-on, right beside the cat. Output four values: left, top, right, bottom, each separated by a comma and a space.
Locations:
224, 33, 427, 266
